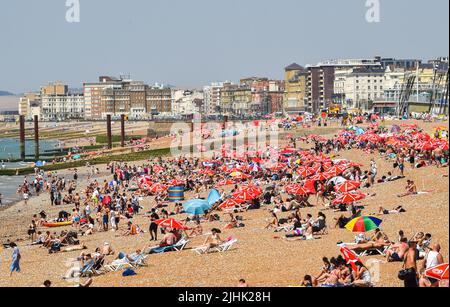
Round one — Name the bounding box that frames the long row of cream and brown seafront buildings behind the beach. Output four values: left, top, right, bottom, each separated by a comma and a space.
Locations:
14, 57, 448, 121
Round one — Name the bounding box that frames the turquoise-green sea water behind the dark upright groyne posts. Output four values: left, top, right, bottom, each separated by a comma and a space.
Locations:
0, 139, 59, 160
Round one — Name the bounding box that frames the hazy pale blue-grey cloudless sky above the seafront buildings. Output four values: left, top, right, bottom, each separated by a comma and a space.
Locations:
0, 0, 449, 93
